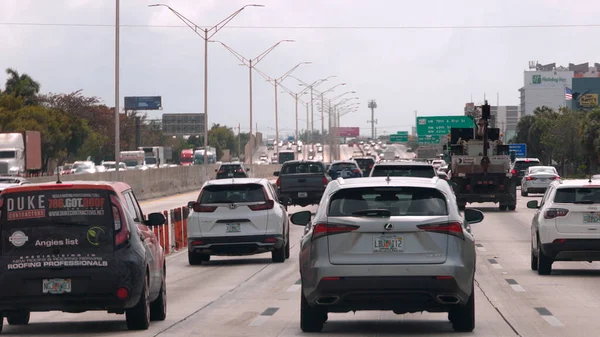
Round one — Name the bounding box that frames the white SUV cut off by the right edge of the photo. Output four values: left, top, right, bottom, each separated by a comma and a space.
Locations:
527, 179, 600, 275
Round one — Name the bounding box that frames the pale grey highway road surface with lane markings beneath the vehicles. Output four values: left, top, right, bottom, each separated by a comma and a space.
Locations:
2, 188, 600, 337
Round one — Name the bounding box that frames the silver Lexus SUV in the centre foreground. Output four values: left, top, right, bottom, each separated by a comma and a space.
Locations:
291, 177, 483, 332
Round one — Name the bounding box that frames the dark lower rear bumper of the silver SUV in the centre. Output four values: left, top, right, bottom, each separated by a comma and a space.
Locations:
306, 276, 471, 313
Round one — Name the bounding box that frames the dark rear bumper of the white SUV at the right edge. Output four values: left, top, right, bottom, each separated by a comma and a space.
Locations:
541, 239, 600, 261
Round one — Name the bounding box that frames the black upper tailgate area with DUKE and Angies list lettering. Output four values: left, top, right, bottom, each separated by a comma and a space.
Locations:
0, 189, 118, 258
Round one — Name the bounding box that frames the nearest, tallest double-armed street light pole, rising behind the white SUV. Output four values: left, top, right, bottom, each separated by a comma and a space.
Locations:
148, 4, 265, 176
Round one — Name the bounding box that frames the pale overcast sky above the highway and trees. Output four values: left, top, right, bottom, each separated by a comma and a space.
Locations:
0, 0, 600, 135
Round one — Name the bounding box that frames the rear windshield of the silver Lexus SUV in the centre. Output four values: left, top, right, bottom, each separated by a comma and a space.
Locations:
328, 187, 448, 216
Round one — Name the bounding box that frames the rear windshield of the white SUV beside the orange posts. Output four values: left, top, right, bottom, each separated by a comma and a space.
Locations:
200, 184, 266, 204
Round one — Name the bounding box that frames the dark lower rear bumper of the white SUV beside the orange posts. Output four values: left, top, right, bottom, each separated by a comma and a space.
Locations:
188, 234, 285, 256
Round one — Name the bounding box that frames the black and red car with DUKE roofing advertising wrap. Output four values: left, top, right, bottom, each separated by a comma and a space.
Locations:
0, 182, 167, 331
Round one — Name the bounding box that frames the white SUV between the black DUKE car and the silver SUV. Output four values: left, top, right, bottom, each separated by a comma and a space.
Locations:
187, 178, 290, 265
